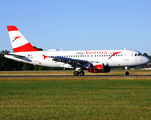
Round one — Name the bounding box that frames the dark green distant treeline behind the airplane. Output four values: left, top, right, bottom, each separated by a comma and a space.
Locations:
0, 50, 151, 71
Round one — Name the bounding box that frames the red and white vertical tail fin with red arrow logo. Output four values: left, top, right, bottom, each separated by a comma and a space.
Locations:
7, 26, 38, 52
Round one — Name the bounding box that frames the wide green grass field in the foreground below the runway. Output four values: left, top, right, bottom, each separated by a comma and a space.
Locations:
0, 78, 151, 120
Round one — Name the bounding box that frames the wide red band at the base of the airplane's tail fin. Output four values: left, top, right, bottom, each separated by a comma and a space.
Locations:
13, 43, 38, 52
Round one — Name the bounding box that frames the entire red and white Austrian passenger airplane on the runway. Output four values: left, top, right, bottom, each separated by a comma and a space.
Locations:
4, 26, 150, 76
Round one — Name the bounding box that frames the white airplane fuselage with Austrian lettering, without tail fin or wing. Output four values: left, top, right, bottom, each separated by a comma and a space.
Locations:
5, 50, 150, 68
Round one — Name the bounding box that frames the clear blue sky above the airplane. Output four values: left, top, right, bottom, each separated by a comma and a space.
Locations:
0, 0, 151, 55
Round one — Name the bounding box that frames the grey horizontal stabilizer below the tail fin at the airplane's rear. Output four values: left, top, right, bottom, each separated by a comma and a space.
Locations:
4, 53, 32, 62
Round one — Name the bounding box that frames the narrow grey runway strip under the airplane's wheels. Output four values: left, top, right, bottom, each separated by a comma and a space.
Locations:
0, 75, 151, 78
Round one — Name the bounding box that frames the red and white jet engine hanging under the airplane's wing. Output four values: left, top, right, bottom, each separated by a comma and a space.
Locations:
88, 63, 110, 73
